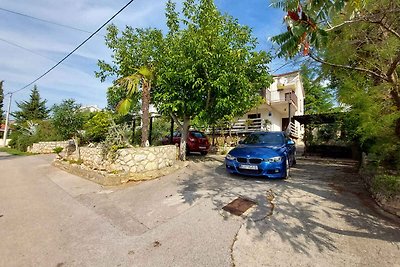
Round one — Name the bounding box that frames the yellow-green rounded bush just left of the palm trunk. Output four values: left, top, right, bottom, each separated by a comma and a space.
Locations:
83, 111, 112, 142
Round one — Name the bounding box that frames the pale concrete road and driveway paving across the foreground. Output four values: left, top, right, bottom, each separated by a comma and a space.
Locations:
0, 153, 400, 266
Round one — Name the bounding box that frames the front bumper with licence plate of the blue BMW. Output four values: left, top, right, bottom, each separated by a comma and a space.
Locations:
225, 158, 286, 178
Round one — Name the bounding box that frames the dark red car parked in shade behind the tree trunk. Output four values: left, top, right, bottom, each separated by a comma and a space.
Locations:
162, 131, 210, 155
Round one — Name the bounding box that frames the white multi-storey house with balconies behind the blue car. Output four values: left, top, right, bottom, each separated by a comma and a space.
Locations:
231, 71, 304, 138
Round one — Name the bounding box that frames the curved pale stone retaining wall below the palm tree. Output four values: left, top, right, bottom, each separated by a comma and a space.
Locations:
68, 145, 177, 173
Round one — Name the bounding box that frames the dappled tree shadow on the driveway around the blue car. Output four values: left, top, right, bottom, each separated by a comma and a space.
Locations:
178, 156, 400, 255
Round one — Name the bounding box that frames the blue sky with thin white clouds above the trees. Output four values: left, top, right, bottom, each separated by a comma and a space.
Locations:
0, 0, 293, 113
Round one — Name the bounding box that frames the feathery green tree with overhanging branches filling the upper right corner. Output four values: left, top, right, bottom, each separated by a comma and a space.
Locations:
273, 0, 400, 168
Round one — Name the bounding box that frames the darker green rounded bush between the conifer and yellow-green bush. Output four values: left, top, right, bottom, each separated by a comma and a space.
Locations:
52, 99, 84, 140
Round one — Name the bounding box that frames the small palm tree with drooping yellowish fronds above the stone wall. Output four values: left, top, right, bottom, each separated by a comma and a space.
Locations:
117, 66, 154, 147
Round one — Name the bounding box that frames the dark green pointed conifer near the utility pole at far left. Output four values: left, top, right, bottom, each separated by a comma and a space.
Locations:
12, 85, 50, 123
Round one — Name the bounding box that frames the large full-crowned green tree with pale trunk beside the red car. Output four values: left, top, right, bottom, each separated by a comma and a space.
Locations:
153, 0, 272, 159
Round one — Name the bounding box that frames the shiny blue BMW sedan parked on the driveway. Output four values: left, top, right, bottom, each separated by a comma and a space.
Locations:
225, 132, 296, 179
